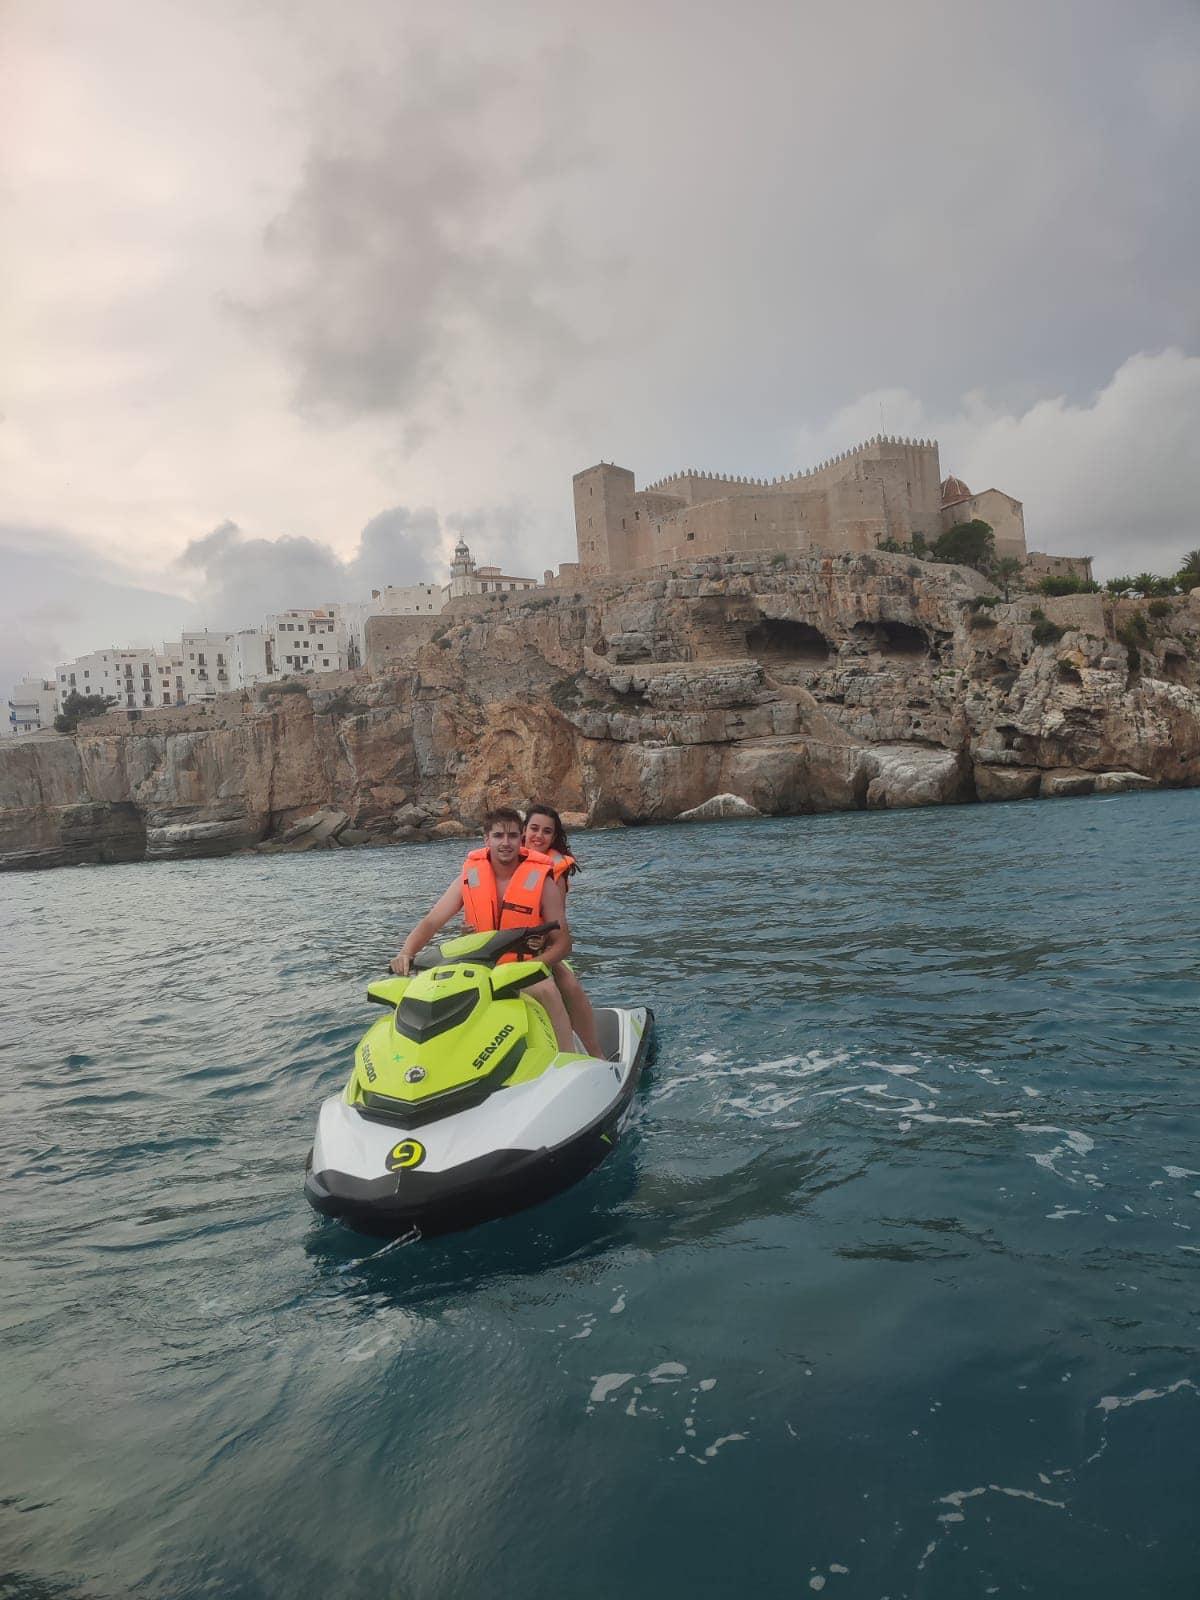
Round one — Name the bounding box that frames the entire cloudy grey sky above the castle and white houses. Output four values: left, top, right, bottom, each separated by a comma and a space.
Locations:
0, 0, 1200, 686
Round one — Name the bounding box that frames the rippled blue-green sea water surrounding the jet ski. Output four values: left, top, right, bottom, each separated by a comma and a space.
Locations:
0, 792, 1200, 1600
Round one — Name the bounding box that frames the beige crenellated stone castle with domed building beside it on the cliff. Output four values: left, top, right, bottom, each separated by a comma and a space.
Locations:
563, 435, 1091, 578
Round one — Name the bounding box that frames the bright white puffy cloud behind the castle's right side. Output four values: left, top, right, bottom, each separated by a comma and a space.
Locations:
795, 349, 1200, 576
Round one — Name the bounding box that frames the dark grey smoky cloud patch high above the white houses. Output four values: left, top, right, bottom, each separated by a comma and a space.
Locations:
240, 43, 588, 437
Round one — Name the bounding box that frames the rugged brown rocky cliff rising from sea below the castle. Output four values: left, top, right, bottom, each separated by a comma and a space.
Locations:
0, 554, 1200, 867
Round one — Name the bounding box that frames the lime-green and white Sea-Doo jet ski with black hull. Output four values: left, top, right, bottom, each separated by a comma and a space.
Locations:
304, 923, 654, 1238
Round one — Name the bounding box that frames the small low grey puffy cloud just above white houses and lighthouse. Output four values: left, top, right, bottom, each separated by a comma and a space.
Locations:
178, 506, 448, 627
